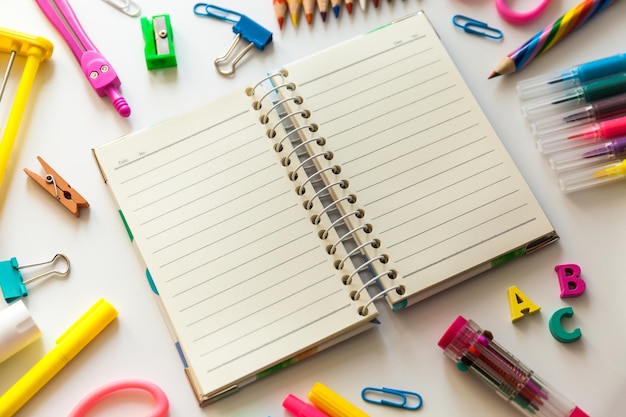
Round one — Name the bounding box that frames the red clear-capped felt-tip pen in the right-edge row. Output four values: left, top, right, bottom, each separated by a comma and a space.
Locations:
537, 116, 626, 153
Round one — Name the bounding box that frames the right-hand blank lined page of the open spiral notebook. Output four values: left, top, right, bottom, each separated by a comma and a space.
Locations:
286, 13, 553, 303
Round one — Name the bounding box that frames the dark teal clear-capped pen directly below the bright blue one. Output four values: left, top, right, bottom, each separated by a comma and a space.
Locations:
522, 72, 626, 120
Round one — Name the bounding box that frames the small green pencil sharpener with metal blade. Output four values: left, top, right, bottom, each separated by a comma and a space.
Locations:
141, 14, 177, 70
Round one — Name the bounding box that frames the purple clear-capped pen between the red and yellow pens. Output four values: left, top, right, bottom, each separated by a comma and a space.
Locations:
549, 136, 626, 172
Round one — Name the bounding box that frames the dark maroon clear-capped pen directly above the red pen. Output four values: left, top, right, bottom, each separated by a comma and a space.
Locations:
530, 94, 626, 136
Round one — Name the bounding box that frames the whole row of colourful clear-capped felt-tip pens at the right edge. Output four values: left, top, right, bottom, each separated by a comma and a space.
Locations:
517, 54, 626, 192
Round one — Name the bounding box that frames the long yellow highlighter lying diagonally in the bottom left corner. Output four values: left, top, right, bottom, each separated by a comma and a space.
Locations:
0, 298, 117, 417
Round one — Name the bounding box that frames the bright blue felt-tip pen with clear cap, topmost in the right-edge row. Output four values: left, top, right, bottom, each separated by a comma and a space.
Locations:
517, 54, 626, 100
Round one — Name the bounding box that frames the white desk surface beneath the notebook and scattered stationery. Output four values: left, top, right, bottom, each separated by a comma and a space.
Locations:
0, 0, 626, 417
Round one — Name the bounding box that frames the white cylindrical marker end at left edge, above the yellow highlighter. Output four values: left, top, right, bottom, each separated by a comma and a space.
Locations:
0, 300, 41, 362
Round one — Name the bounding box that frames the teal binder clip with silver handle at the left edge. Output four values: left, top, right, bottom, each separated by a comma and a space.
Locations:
0, 253, 70, 304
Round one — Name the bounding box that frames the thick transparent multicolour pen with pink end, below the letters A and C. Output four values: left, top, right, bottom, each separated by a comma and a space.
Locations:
439, 316, 589, 417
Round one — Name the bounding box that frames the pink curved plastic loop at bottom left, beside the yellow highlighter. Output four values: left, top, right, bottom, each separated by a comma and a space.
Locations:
68, 379, 170, 417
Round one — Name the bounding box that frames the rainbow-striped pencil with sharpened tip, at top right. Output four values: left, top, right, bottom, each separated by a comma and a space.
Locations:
489, 0, 617, 78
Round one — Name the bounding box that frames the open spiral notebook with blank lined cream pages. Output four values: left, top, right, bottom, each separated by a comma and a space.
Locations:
93, 12, 558, 405
